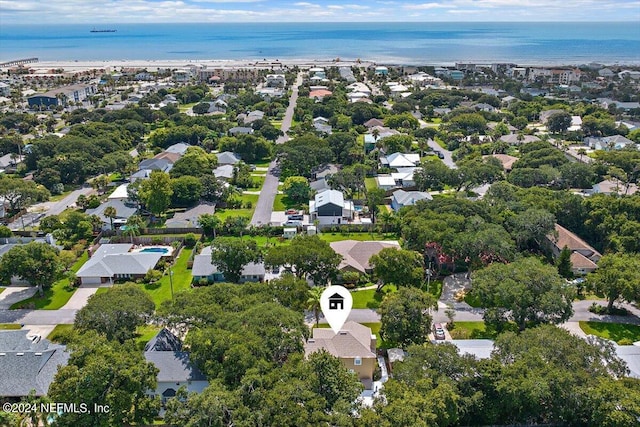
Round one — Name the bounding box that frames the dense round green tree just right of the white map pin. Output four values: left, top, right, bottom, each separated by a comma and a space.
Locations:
379, 288, 438, 347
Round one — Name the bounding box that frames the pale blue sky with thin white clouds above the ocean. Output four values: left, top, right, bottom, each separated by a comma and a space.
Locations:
0, 0, 640, 26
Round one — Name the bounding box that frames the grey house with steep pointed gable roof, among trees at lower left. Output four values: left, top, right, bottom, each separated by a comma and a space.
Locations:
144, 328, 209, 403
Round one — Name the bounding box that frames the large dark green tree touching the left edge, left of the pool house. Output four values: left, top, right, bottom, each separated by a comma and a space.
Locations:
0, 242, 64, 296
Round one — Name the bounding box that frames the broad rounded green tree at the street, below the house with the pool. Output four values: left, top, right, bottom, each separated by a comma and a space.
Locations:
74, 283, 155, 343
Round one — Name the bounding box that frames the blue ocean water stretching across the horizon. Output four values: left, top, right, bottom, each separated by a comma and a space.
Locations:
0, 22, 640, 64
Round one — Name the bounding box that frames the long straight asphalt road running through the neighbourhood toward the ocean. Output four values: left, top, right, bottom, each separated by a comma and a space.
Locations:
251, 73, 302, 226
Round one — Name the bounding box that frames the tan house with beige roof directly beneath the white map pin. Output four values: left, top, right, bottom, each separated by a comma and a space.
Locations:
304, 321, 377, 390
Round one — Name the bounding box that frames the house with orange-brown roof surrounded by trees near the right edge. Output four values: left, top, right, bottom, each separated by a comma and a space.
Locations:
547, 224, 602, 275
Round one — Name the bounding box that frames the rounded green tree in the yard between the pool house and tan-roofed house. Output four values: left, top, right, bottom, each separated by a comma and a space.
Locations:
211, 237, 261, 283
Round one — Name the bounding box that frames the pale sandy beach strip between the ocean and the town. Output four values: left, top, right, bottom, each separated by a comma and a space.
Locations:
6, 58, 640, 71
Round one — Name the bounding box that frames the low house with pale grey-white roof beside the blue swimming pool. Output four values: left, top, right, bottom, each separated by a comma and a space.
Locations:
76, 243, 164, 285
